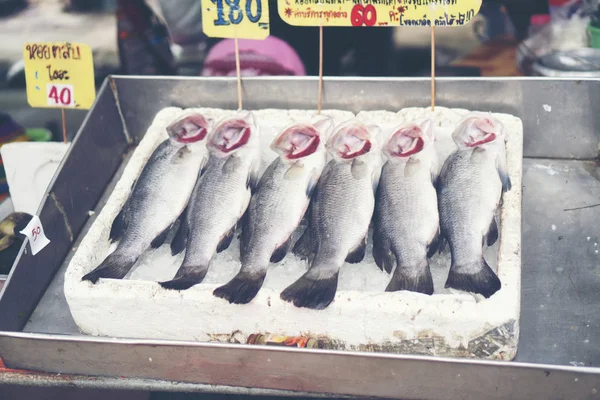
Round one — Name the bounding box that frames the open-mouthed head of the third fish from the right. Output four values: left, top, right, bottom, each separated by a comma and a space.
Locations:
327, 121, 373, 160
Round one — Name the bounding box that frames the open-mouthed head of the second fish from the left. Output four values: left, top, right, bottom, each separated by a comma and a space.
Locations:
207, 113, 256, 154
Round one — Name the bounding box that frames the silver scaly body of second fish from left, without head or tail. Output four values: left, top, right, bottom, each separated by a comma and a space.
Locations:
182, 154, 250, 266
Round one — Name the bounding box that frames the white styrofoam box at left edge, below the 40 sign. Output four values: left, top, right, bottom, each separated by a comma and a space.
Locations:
0, 142, 70, 214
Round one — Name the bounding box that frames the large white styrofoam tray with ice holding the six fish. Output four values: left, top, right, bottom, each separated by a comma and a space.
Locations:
64, 108, 523, 359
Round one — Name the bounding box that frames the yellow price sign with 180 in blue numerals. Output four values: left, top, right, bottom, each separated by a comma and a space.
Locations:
201, 0, 269, 40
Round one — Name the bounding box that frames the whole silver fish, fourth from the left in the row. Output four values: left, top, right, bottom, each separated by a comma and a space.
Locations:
280, 120, 381, 310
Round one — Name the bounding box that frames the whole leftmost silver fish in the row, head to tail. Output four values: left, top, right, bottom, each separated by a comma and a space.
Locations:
82, 113, 212, 283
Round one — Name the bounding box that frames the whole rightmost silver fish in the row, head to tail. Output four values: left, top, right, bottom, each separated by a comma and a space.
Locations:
437, 113, 511, 298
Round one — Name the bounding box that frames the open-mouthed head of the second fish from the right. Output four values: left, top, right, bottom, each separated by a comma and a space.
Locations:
383, 119, 435, 159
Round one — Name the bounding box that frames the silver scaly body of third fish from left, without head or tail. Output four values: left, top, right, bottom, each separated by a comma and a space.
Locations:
241, 158, 312, 268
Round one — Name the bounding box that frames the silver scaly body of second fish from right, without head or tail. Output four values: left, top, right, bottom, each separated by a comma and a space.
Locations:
375, 162, 439, 267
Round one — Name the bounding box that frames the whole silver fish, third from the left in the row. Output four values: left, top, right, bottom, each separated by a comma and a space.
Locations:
213, 117, 333, 304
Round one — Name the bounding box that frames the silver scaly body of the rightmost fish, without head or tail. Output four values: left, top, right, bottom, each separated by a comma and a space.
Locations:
438, 148, 502, 272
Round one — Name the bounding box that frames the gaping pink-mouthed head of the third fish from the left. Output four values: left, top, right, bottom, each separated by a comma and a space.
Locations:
271, 124, 321, 160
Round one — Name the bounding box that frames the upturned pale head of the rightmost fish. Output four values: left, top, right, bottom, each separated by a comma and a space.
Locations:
452, 113, 504, 149
